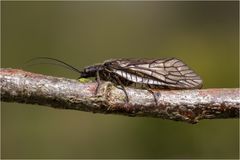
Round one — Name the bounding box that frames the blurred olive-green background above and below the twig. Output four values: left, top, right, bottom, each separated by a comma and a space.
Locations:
1, 1, 239, 159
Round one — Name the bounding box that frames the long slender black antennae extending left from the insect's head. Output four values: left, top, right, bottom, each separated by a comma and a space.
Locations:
26, 57, 82, 73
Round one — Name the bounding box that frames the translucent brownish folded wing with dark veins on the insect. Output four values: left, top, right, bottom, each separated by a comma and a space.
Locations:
107, 58, 202, 89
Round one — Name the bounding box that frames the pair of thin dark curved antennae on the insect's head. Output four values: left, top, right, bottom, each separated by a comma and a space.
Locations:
25, 57, 82, 74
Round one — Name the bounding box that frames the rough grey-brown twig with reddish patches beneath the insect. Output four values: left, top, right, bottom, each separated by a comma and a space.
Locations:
0, 68, 240, 123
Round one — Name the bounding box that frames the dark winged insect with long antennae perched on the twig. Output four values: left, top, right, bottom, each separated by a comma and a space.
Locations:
27, 57, 202, 102
